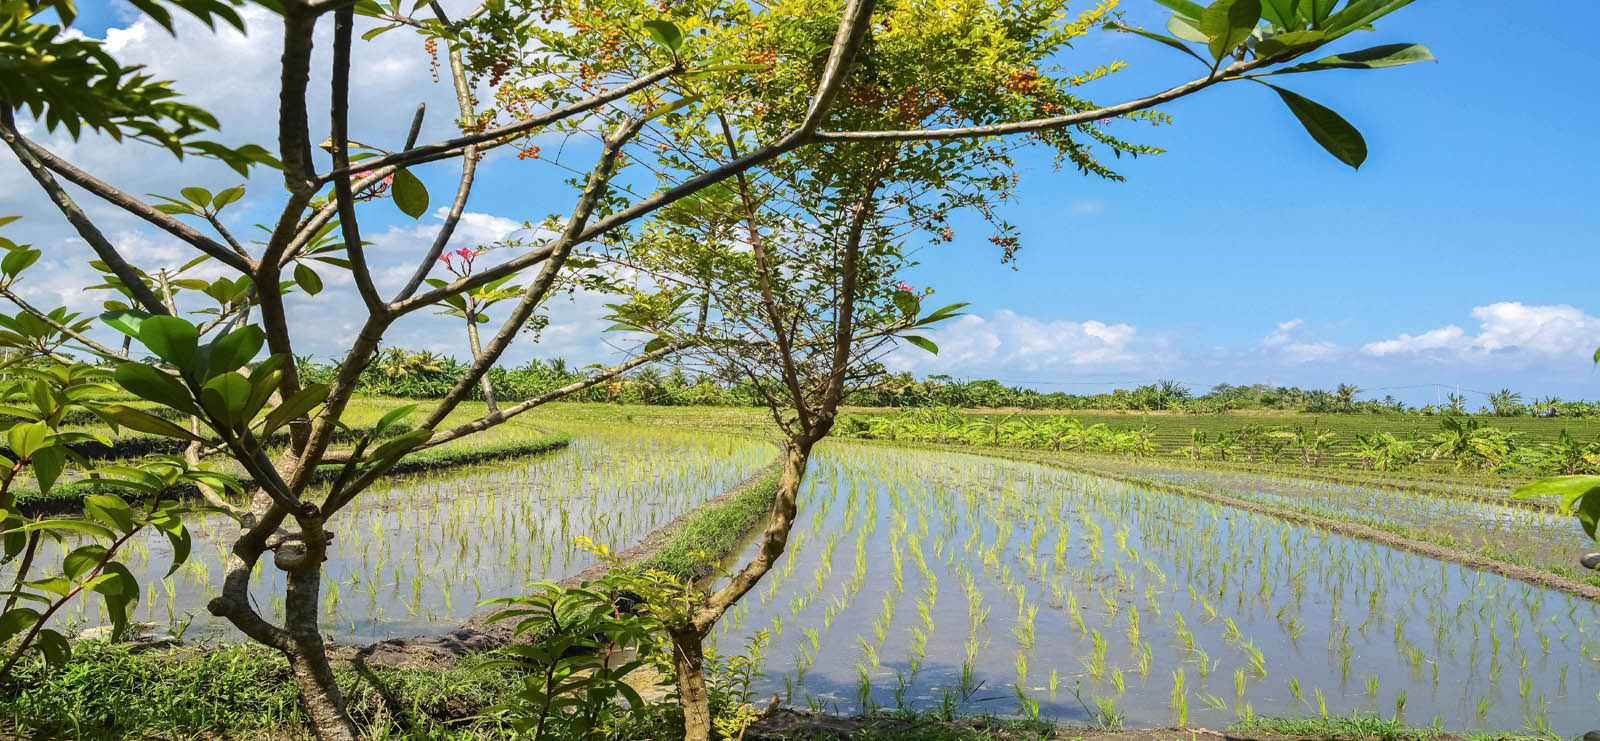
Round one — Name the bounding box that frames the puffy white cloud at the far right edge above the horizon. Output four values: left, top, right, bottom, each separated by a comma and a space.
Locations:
1362, 301, 1600, 366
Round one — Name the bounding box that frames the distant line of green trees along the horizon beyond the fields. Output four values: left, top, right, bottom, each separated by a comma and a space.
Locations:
284, 347, 1600, 418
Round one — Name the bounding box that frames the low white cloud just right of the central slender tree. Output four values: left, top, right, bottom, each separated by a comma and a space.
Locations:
886, 309, 1154, 375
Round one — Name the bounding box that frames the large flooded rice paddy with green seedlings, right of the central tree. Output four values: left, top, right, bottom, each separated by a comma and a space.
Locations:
718, 445, 1600, 736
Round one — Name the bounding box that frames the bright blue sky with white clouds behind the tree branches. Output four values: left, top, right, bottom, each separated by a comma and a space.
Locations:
12, 0, 1600, 403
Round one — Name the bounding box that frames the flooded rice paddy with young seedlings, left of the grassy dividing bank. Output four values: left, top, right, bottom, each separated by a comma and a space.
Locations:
29, 427, 773, 643
